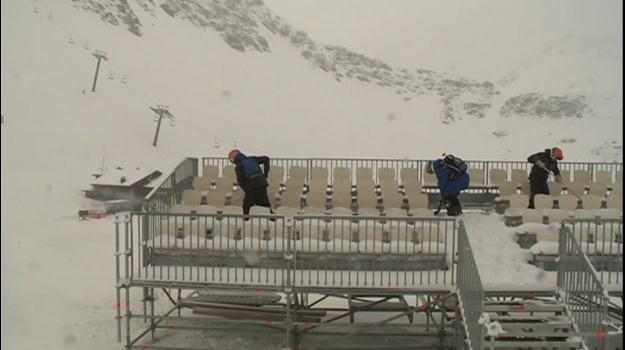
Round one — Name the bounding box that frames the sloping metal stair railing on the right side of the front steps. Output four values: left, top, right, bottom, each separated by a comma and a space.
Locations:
558, 222, 609, 349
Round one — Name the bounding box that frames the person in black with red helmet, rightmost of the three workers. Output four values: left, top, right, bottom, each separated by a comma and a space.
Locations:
527, 147, 564, 209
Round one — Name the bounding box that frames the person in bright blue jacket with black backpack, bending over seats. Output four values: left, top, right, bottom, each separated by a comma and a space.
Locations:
426, 159, 469, 216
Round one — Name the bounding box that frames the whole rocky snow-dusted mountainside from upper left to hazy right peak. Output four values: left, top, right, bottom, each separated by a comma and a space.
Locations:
61, 0, 622, 159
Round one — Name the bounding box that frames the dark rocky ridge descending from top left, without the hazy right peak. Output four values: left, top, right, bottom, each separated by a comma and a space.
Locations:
69, 0, 497, 123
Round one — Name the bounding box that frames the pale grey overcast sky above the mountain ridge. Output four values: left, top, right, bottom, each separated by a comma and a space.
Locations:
265, 0, 623, 80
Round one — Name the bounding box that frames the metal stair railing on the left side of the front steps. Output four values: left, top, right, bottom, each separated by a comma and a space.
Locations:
457, 221, 485, 349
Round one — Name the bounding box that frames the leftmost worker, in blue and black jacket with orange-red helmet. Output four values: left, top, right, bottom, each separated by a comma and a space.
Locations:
228, 149, 273, 215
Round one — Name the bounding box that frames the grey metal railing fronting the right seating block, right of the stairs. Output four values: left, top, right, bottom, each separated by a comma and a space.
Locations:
563, 218, 623, 289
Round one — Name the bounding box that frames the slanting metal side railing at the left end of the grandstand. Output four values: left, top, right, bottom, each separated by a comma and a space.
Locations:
143, 158, 198, 213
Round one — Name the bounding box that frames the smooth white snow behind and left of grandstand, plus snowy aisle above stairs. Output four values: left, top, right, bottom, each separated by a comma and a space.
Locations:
0, 0, 622, 349
